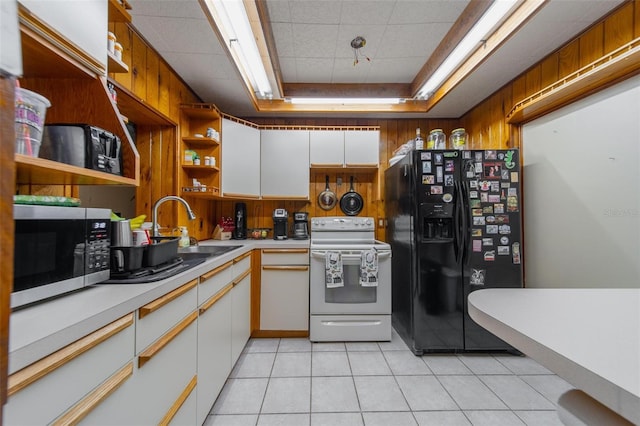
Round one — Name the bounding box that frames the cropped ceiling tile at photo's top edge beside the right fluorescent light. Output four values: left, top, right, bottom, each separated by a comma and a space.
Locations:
389, 0, 469, 25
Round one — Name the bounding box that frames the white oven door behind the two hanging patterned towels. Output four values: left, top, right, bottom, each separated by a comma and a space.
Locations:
309, 249, 391, 315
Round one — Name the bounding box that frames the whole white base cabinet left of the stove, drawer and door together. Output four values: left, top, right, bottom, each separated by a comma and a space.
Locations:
260, 249, 309, 331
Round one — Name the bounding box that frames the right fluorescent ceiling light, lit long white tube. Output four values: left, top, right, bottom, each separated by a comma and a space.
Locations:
418, 0, 517, 98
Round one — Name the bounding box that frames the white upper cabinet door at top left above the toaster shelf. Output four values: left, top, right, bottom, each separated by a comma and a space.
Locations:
17, 0, 109, 70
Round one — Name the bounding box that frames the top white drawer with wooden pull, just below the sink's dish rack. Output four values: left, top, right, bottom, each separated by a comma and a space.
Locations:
136, 279, 198, 354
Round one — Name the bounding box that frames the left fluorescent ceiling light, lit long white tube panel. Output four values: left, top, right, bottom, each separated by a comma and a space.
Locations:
206, 0, 272, 98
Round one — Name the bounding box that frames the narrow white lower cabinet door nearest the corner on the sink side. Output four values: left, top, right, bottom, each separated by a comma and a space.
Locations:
231, 270, 251, 364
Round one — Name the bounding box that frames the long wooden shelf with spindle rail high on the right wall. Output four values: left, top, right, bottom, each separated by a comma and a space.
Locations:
507, 38, 640, 124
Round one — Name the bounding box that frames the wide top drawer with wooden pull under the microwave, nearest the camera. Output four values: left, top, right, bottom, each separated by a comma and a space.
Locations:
4, 314, 135, 425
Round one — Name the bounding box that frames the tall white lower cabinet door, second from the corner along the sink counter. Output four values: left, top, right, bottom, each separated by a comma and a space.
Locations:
196, 283, 233, 425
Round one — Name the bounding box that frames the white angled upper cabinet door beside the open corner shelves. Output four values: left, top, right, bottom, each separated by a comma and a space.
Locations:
222, 119, 260, 198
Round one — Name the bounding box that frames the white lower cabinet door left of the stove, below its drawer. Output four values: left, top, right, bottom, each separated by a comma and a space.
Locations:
260, 265, 309, 330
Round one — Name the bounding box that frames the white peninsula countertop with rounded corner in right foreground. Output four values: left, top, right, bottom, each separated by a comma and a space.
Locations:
469, 289, 640, 424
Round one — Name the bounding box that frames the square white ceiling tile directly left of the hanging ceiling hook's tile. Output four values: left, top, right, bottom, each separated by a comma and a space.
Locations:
293, 24, 338, 58
